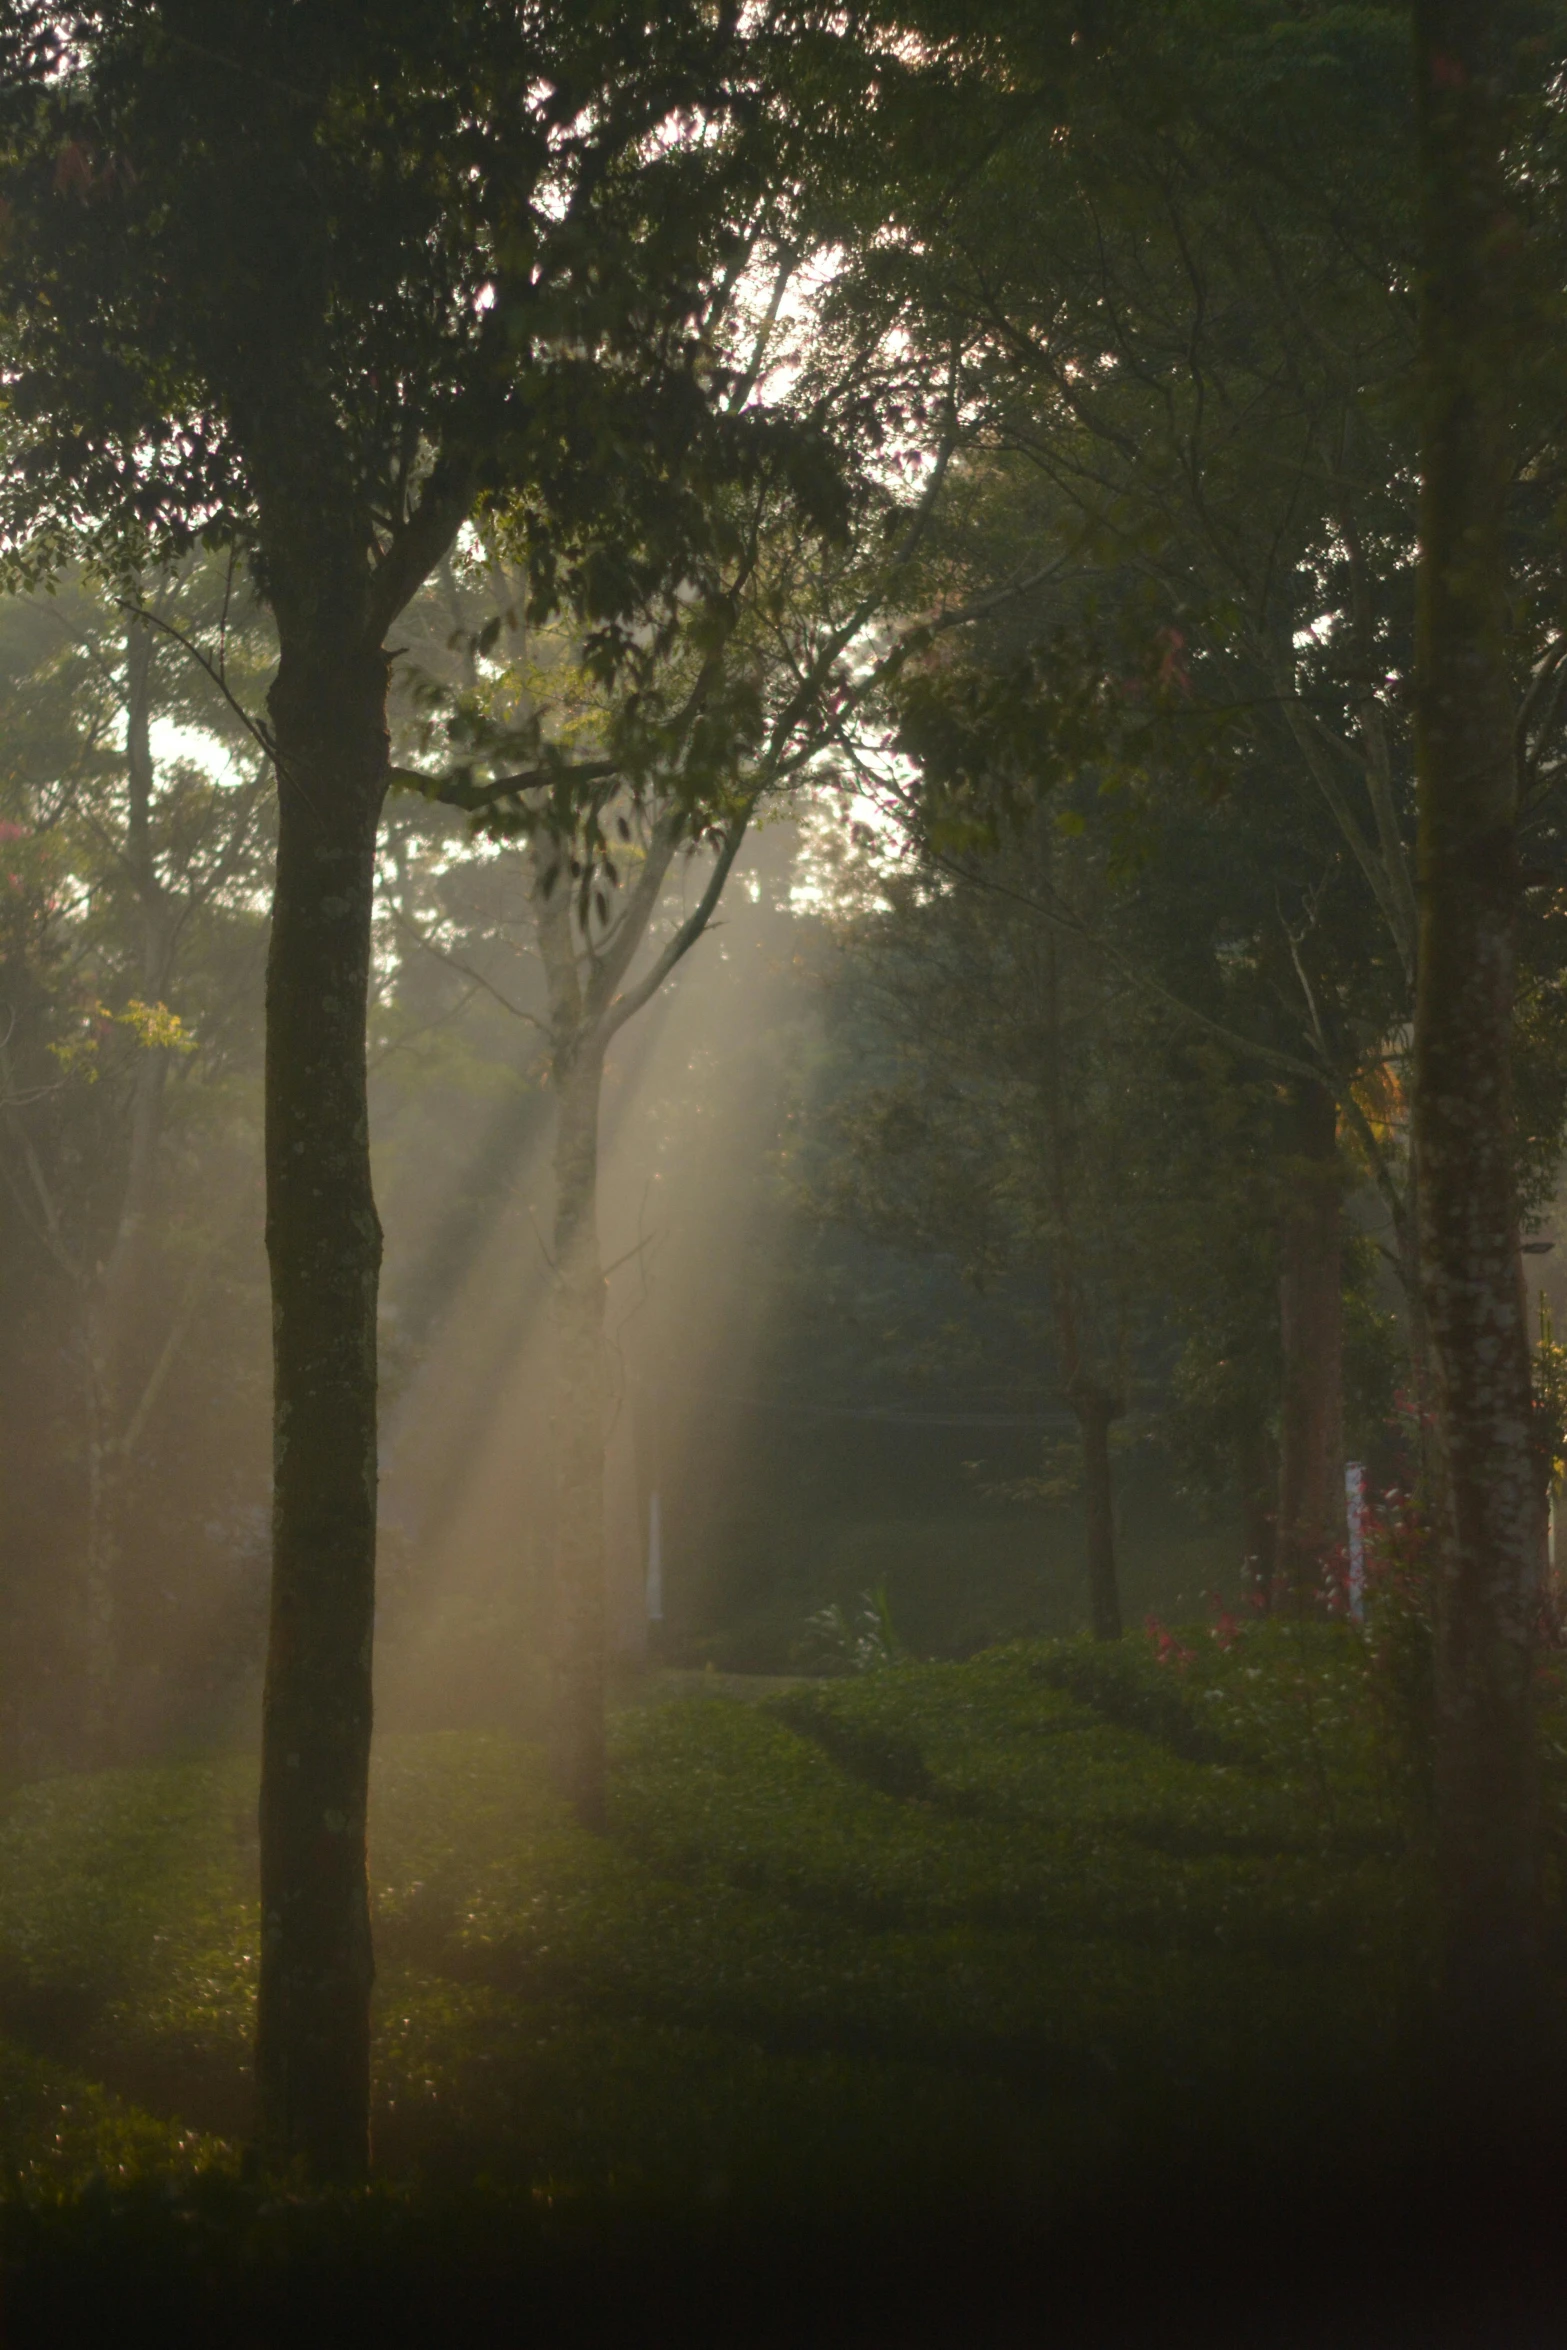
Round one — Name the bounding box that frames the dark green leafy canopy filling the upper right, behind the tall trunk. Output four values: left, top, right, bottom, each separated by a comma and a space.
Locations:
839, 5, 1565, 1381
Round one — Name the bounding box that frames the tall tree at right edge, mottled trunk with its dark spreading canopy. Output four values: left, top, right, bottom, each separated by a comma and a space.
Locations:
881, 5, 1567, 2045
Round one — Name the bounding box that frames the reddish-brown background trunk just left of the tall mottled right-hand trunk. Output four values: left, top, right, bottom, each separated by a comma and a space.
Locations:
1273, 1086, 1344, 1610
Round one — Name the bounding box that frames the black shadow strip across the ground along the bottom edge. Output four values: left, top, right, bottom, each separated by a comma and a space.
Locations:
0, 2096, 1567, 2350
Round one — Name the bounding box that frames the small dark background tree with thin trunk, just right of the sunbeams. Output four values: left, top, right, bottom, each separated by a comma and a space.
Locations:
806, 811, 1156, 1640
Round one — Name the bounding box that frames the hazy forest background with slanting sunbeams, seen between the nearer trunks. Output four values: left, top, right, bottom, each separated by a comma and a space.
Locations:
0, 549, 1558, 1770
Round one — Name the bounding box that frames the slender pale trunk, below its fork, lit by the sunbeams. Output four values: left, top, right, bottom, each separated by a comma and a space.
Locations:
550, 1032, 606, 1828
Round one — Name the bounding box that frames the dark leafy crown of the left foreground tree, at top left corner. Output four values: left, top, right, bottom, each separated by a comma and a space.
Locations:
0, 0, 920, 665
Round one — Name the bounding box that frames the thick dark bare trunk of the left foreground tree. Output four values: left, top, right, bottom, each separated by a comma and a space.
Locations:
256, 632, 388, 2178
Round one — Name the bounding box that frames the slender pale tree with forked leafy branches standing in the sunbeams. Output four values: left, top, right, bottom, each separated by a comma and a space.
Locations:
389, 347, 958, 1828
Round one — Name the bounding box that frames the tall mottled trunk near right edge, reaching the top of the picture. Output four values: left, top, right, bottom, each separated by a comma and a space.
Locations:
1414, 0, 1539, 2084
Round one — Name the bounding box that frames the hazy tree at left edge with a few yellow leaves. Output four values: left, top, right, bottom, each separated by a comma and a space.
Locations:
0, 566, 270, 1763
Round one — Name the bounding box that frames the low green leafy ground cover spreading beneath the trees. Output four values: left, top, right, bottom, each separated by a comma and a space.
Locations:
0, 1626, 1560, 2343
